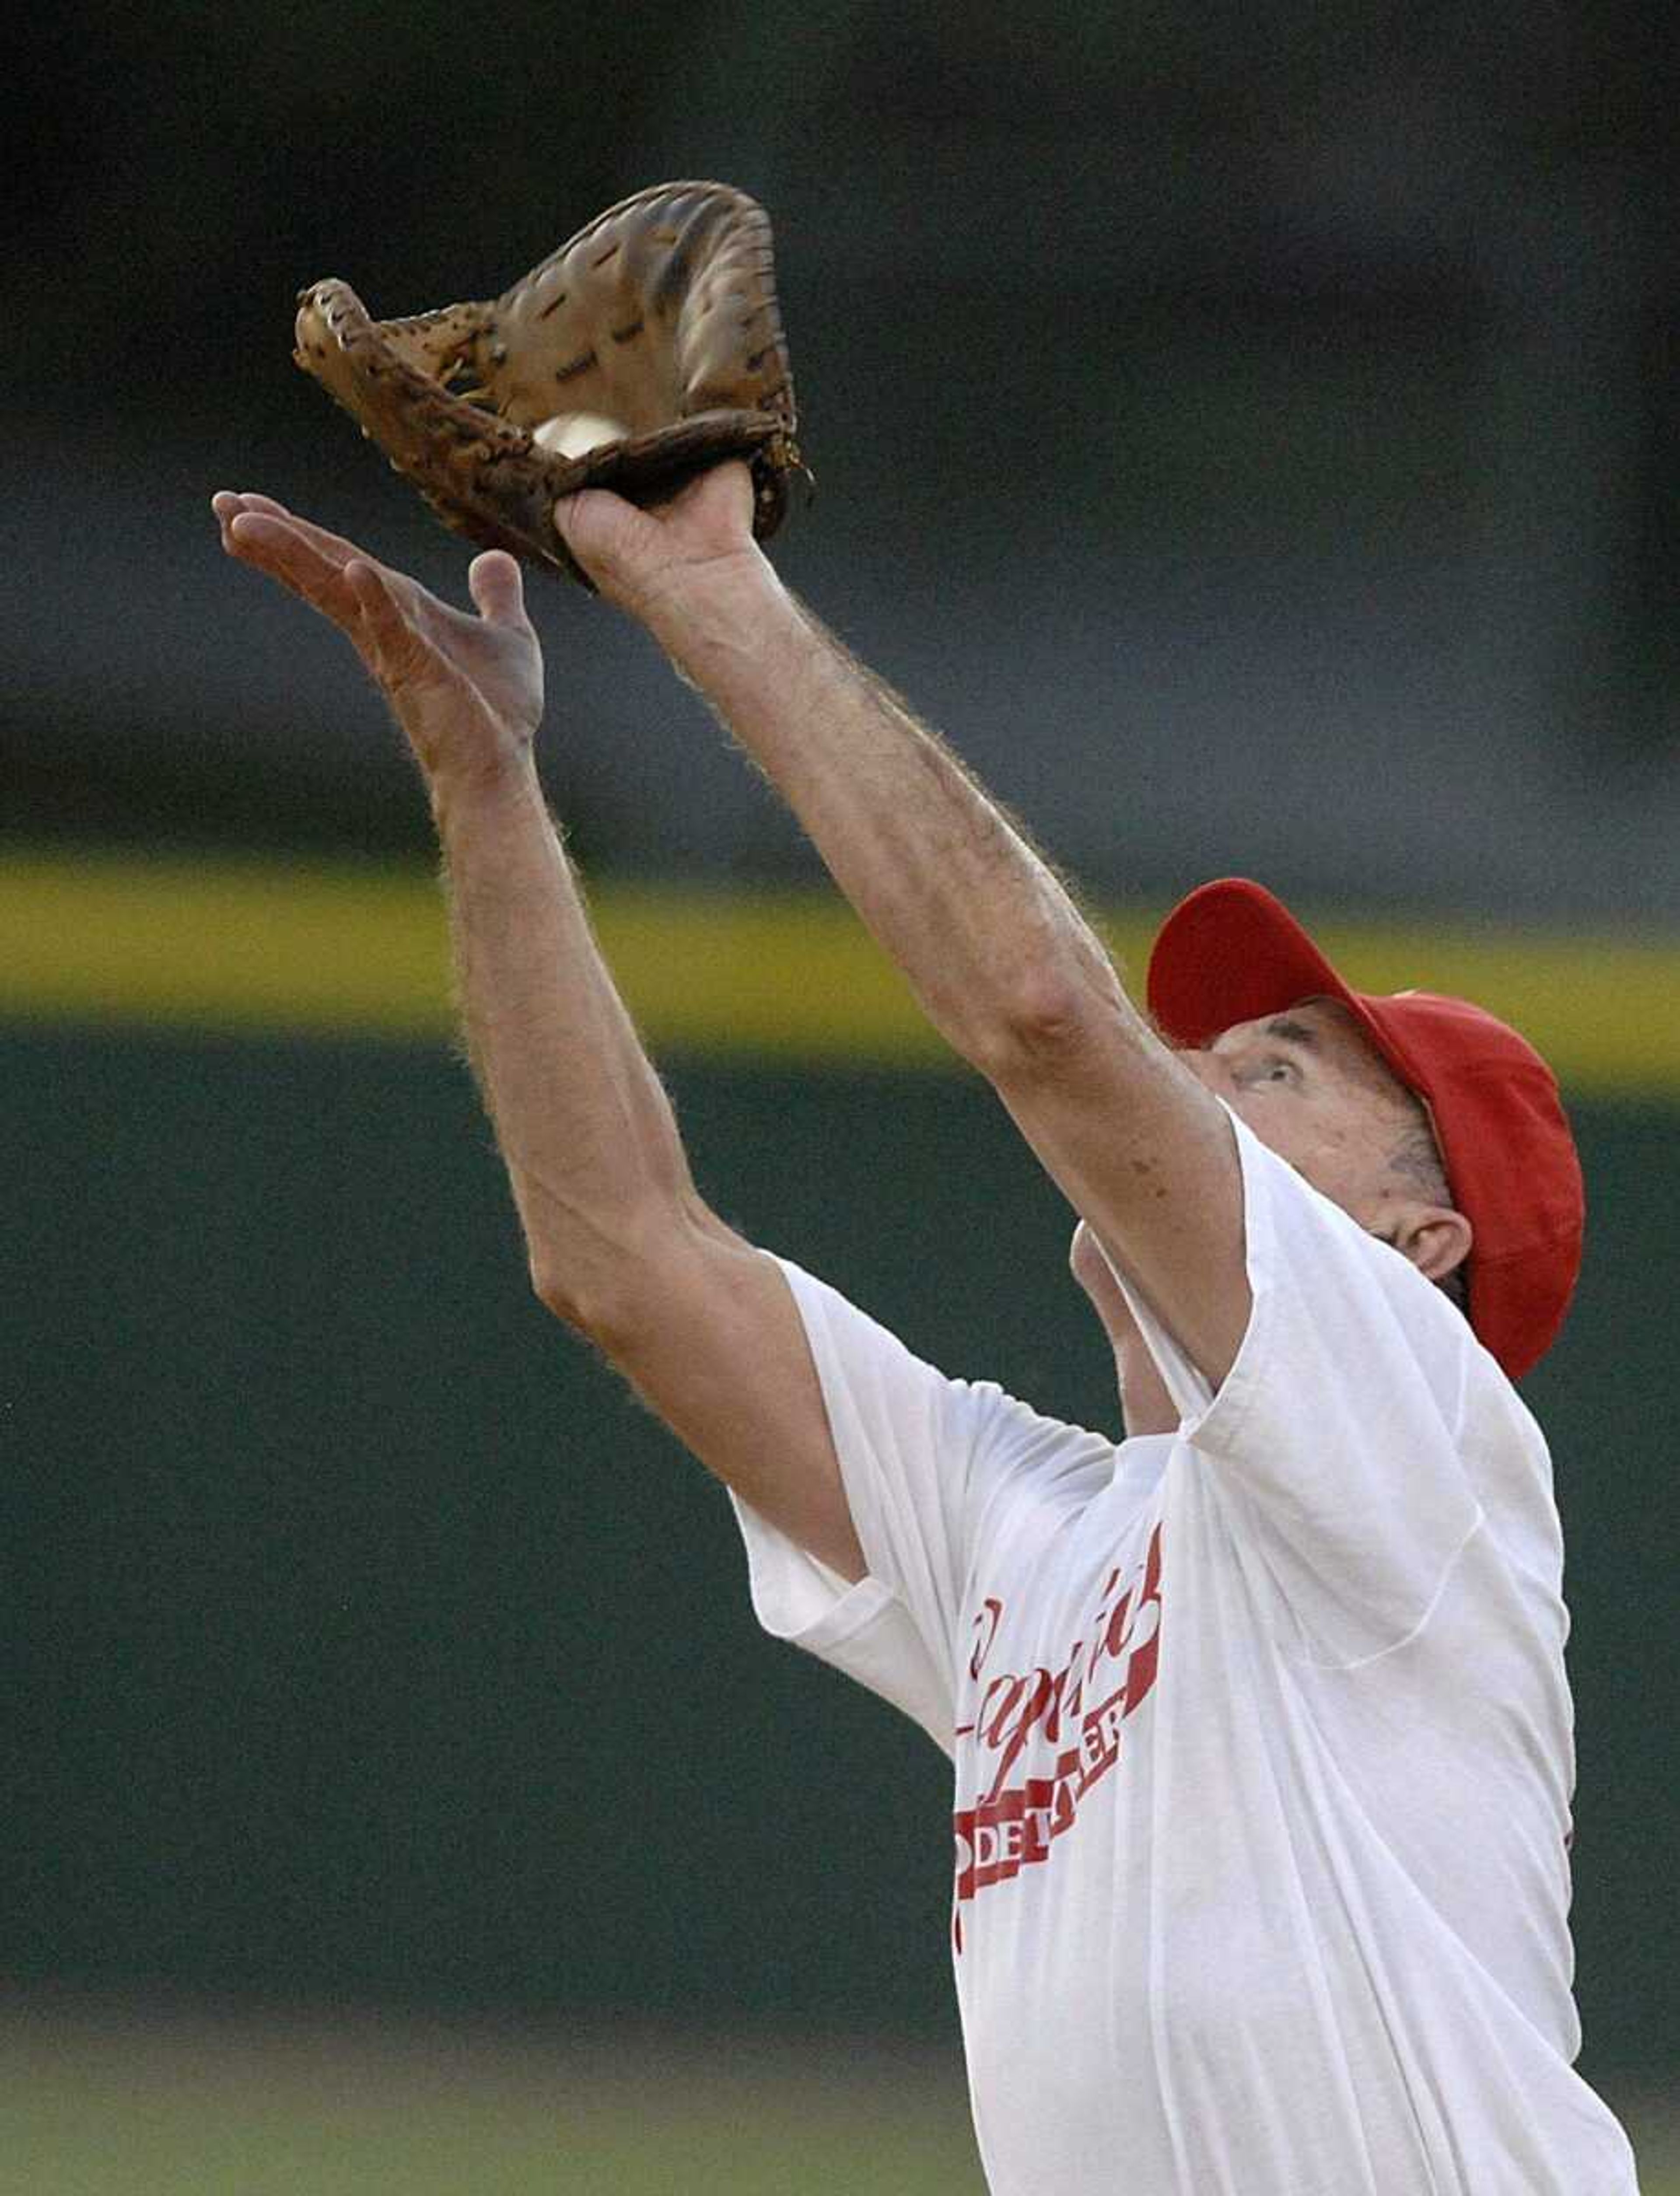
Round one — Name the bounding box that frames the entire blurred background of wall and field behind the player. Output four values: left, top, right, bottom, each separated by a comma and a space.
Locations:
0, 0, 1680, 2196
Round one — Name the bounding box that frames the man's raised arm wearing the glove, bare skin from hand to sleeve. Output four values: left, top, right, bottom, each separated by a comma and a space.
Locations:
556, 465, 1250, 1384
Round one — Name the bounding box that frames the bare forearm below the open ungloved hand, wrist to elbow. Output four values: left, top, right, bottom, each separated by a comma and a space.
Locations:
433, 764, 690, 1326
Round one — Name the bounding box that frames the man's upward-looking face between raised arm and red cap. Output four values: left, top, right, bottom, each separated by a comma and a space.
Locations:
1180, 999, 1414, 1225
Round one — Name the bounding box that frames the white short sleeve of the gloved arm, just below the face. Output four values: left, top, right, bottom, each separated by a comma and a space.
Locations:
1116, 1115, 1484, 1658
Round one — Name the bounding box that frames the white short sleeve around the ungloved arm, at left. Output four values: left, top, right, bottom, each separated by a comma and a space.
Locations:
734, 1258, 1113, 1752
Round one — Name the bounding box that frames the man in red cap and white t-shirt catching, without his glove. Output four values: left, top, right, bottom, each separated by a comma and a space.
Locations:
215, 463, 1636, 2196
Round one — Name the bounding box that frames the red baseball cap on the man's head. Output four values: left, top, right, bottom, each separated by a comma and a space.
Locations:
1148, 876, 1586, 1379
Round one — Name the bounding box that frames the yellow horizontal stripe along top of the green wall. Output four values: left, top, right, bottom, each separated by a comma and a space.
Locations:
0, 854, 1680, 1098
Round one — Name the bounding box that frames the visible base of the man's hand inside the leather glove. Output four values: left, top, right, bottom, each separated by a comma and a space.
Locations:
553, 459, 771, 626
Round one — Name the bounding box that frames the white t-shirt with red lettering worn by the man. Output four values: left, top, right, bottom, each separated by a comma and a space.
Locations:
736, 1122, 1636, 2196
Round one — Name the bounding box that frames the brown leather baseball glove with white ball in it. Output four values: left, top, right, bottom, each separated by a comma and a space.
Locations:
294, 182, 804, 586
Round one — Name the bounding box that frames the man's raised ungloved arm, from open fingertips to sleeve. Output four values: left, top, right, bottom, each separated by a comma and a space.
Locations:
215, 492, 863, 1577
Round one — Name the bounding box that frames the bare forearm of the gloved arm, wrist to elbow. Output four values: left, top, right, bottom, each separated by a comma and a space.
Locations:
650, 571, 1122, 1070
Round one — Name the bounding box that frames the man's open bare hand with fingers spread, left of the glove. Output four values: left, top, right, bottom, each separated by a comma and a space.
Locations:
211, 490, 538, 784
